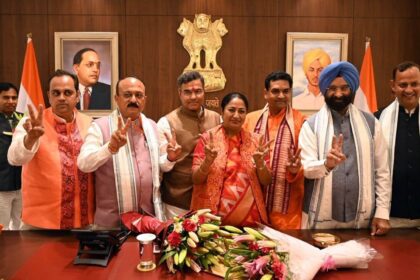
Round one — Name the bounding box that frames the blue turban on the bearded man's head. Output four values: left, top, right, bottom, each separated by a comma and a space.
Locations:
319, 61, 360, 95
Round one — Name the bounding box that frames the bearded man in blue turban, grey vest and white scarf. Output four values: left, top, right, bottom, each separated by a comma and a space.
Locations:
299, 62, 391, 235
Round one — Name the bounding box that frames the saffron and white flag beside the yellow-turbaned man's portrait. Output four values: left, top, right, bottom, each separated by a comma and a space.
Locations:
354, 38, 378, 113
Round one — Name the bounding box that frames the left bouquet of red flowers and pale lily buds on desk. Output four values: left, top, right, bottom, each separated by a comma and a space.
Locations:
159, 209, 241, 276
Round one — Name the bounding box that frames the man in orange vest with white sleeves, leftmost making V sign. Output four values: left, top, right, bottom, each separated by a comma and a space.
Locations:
8, 70, 94, 229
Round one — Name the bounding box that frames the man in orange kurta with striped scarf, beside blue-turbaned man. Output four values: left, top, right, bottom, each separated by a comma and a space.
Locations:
244, 71, 305, 229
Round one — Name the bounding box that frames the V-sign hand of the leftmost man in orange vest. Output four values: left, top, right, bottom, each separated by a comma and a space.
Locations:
23, 105, 45, 150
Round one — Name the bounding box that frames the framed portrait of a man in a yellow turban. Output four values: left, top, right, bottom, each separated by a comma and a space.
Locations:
286, 32, 348, 115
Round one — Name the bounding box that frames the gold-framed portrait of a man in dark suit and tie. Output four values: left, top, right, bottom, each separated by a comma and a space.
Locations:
54, 32, 118, 117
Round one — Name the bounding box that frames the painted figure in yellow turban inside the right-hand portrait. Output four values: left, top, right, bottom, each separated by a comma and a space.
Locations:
293, 48, 331, 110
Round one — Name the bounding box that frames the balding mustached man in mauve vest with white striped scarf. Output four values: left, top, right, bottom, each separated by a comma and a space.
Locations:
77, 77, 180, 228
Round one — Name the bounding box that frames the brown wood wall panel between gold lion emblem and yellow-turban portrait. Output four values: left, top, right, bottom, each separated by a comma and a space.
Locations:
218, 17, 281, 110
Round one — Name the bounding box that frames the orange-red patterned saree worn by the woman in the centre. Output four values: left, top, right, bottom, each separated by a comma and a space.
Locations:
191, 126, 268, 226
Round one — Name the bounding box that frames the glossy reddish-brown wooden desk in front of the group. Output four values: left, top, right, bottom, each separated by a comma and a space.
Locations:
0, 229, 420, 280
